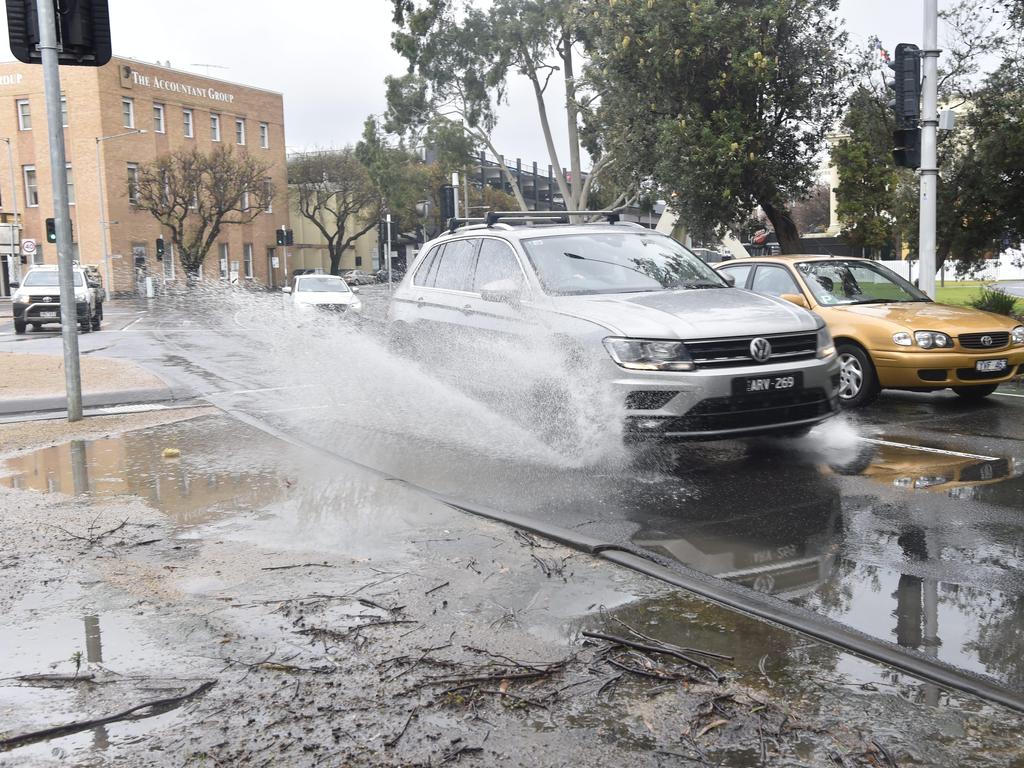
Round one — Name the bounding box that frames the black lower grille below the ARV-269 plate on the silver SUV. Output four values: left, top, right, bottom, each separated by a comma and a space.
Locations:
664, 389, 834, 432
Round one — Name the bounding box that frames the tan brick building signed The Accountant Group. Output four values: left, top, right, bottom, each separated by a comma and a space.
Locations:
0, 58, 288, 295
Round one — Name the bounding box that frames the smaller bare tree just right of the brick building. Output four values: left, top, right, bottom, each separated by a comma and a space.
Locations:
288, 146, 380, 274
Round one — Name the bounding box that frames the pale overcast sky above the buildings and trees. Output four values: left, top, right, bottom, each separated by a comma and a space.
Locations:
0, 0, 966, 165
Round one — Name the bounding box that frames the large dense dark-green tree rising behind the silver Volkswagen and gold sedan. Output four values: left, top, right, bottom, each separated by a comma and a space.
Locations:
582, 0, 846, 251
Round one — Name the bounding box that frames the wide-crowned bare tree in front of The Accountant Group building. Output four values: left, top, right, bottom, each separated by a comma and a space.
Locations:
134, 146, 274, 281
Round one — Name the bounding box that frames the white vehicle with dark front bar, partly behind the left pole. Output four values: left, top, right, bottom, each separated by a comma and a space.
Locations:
11, 265, 102, 334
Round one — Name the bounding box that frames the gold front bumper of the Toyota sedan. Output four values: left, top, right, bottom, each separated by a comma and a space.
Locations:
870, 346, 1024, 389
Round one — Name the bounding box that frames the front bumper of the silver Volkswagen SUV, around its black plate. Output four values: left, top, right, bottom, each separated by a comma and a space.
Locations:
611, 355, 840, 440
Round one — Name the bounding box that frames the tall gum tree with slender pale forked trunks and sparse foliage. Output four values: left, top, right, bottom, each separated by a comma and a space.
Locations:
386, 0, 612, 210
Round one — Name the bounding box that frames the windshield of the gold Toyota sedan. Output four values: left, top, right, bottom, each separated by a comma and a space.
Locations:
797, 259, 931, 306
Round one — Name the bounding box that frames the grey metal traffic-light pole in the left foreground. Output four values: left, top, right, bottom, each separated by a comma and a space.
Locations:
36, 2, 82, 421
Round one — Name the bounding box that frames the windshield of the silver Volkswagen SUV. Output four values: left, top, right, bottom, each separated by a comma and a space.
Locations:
522, 232, 727, 296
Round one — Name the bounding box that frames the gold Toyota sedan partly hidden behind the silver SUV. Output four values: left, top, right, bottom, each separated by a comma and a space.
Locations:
717, 255, 1024, 407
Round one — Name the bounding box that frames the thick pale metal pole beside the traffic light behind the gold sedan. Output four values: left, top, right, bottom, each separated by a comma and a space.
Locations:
918, 0, 939, 299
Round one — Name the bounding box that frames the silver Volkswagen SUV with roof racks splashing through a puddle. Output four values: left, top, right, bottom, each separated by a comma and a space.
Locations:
388, 212, 839, 439
